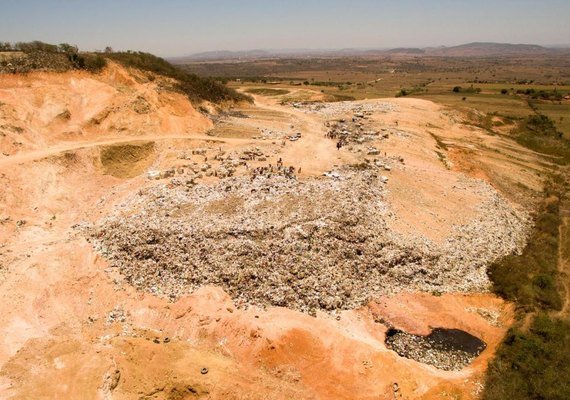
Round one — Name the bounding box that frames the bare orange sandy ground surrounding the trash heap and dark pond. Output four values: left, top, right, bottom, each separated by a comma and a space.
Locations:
0, 72, 540, 399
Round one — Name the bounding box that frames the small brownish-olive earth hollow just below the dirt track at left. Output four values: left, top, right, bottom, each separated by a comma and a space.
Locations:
100, 142, 155, 178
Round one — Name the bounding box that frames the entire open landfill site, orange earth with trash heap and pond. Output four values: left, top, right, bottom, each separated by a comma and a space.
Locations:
0, 62, 545, 400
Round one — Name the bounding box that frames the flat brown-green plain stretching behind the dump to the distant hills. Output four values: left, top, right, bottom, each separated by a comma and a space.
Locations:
183, 55, 570, 137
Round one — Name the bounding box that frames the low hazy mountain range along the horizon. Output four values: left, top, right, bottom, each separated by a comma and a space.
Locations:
169, 42, 570, 64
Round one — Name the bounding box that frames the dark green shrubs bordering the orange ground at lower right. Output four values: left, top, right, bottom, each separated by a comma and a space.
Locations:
483, 105, 570, 400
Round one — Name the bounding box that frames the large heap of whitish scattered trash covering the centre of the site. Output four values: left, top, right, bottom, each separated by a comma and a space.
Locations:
86, 166, 529, 315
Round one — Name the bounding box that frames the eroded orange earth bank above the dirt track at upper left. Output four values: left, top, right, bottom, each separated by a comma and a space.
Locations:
0, 63, 212, 157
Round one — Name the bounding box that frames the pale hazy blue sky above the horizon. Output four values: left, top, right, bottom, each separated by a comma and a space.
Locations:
0, 0, 570, 56
